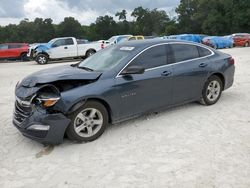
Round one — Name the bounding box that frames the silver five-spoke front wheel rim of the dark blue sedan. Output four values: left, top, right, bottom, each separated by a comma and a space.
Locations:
74, 108, 103, 138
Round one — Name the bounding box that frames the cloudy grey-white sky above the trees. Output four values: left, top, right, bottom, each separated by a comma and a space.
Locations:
0, 0, 180, 26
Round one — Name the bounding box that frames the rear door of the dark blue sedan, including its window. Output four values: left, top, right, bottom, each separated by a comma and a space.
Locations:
169, 43, 213, 104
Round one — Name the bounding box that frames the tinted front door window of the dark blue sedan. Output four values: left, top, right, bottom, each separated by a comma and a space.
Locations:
131, 45, 167, 69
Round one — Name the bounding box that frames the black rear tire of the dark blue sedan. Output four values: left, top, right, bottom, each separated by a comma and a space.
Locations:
200, 75, 223, 106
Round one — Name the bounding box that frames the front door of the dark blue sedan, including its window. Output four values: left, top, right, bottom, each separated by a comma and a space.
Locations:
116, 44, 173, 118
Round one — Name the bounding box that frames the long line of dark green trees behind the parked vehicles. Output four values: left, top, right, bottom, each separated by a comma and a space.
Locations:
0, 0, 250, 43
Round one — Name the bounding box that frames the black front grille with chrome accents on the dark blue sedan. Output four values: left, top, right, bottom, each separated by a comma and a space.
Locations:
13, 101, 32, 125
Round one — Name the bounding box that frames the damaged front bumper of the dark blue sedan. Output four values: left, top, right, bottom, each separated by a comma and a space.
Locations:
13, 101, 70, 145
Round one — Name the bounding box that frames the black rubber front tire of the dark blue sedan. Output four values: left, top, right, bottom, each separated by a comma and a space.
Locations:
66, 101, 108, 142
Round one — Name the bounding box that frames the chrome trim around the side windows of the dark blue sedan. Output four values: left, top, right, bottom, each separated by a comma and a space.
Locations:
115, 42, 215, 78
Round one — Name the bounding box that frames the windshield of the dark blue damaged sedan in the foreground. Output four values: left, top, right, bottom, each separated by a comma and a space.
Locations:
78, 46, 134, 72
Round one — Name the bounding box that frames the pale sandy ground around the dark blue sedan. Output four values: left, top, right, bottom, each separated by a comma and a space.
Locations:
0, 48, 250, 188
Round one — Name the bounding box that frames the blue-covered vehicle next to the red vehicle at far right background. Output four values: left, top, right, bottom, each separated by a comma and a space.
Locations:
202, 36, 234, 49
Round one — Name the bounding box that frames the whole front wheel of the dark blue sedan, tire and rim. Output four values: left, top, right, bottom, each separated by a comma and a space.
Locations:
66, 101, 108, 142
